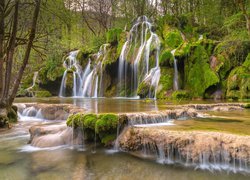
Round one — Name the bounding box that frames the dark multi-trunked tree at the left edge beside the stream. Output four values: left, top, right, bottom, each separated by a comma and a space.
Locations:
0, 0, 41, 126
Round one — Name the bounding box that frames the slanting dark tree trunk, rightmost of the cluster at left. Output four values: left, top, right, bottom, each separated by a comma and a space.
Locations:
8, 0, 41, 105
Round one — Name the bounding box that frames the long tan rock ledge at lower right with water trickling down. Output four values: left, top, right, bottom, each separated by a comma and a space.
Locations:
119, 128, 250, 168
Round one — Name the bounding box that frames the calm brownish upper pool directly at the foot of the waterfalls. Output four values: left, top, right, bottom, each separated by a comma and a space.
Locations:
15, 97, 244, 113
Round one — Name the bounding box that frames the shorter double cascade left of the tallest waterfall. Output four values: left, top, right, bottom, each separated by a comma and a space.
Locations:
59, 44, 108, 98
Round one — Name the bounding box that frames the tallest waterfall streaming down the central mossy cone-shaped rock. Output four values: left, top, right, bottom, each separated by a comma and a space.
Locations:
118, 16, 160, 98
